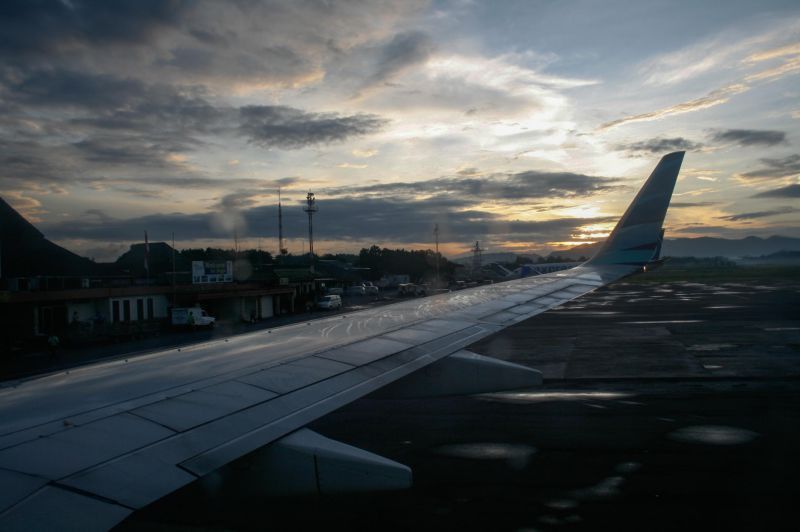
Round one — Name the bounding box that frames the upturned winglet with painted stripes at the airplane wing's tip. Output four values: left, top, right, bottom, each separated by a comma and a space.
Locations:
587, 151, 685, 266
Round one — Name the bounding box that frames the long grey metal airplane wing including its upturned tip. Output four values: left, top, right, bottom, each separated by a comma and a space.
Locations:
0, 152, 683, 530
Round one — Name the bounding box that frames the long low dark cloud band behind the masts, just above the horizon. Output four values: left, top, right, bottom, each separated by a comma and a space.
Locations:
41, 197, 615, 243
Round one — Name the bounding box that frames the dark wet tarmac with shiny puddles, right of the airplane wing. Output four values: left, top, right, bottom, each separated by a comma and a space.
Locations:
120, 281, 800, 531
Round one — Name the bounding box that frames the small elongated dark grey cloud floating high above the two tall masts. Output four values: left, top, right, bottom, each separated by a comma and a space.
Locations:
239, 105, 386, 149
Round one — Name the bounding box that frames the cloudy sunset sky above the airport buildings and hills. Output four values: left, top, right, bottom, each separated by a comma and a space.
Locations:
0, 0, 800, 260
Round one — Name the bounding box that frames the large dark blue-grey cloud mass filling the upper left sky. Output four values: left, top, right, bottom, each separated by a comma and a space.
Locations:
0, 0, 412, 192
